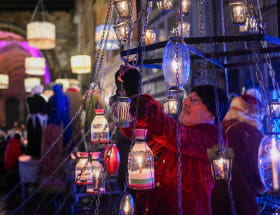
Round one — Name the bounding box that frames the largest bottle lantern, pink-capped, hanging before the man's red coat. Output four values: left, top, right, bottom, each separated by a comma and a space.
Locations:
128, 129, 155, 190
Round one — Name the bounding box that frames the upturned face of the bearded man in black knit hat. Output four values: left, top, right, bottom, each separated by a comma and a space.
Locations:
179, 92, 215, 126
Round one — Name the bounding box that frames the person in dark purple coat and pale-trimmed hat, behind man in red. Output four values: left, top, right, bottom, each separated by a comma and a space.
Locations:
213, 95, 265, 215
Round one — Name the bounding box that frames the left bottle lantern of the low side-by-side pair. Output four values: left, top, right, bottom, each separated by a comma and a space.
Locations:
75, 152, 92, 185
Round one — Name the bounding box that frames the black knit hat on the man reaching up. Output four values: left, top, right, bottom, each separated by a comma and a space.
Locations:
191, 85, 229, 124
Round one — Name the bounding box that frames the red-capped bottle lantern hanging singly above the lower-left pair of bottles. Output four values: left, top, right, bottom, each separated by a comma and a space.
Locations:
91, 109, 110, 143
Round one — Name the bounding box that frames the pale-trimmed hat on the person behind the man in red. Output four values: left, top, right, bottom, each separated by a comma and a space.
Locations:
230, 95, 265, 119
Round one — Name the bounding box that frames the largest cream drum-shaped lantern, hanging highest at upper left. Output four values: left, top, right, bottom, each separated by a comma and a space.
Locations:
27, 21, 56, 49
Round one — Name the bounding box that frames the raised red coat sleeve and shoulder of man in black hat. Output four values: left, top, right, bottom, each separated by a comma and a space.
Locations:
123, 95, 217, 160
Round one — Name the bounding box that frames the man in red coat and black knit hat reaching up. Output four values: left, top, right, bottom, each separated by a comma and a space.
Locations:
117, 66, 228, 215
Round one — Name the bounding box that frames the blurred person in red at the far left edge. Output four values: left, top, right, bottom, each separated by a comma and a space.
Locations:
4, 133, 22, 188
